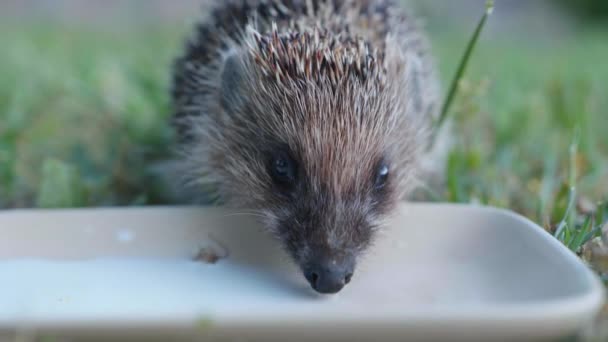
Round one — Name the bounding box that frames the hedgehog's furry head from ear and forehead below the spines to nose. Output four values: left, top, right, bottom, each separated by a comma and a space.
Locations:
211, 42, 426, 293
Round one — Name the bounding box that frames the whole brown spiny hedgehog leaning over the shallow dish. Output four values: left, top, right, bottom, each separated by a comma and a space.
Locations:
172, 0, 440, 294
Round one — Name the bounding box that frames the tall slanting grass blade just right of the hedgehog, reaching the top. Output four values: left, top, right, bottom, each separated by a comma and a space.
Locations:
433, 0, 494, 140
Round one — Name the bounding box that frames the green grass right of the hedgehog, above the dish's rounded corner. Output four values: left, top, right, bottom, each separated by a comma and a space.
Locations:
438, 26, 608, 258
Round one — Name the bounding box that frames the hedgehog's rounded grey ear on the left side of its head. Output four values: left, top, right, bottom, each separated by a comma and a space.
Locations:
220, 52, 246, 112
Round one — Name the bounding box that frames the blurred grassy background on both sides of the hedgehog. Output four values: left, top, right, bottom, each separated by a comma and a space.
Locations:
0, 0, 608, 250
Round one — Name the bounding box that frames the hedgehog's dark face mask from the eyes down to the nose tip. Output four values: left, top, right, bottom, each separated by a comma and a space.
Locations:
262, 141, 392, 293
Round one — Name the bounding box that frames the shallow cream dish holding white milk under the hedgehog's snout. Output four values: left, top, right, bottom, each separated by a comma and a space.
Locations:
0, 204, 604, 341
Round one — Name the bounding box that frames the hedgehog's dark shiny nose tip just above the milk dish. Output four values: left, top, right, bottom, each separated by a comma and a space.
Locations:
304, 258, 355, 294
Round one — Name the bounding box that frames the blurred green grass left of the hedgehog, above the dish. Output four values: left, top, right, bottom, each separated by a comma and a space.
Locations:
0, 23, 181, 207
